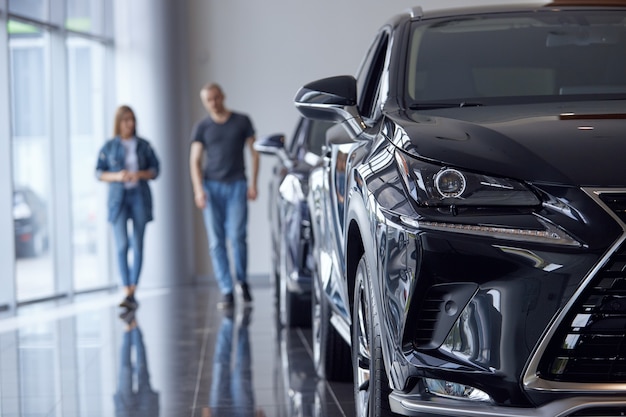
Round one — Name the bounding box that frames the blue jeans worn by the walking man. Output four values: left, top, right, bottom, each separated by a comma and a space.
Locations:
203, 180, 248, 294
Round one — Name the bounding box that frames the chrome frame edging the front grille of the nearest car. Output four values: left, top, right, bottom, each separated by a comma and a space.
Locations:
523, 188, 626, 393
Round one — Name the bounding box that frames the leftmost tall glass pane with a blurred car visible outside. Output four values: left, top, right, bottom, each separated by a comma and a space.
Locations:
9, 21, 54, 300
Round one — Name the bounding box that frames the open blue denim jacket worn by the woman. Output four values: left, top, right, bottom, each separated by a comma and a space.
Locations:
96, 136, 159, 222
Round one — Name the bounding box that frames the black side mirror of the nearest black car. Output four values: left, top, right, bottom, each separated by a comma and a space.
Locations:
294, 75, 365, 136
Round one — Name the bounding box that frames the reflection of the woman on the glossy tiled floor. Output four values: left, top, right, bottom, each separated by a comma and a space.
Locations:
113, 312, 159, 417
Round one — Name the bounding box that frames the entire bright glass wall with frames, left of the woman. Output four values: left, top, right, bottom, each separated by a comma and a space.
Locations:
0, 0, 116, 304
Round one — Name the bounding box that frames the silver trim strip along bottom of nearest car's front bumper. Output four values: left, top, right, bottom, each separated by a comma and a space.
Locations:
389, 392, 626, 417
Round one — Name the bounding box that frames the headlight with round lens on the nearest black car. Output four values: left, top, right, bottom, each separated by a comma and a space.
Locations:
396, 152, 541, 207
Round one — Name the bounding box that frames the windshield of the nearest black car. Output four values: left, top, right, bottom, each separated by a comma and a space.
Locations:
406, 9, 626, 107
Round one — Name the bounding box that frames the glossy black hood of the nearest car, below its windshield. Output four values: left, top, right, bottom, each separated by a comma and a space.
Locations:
391, 100, 626, 187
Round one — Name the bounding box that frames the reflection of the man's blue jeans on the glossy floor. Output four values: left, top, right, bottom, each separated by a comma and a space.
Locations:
202, 308, 265, 417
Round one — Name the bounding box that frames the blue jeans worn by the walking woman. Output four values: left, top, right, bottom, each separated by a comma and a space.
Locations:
113, 188, 147, 287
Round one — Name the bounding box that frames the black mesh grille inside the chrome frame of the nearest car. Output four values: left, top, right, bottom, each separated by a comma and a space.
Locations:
538, 193, 626, 383
